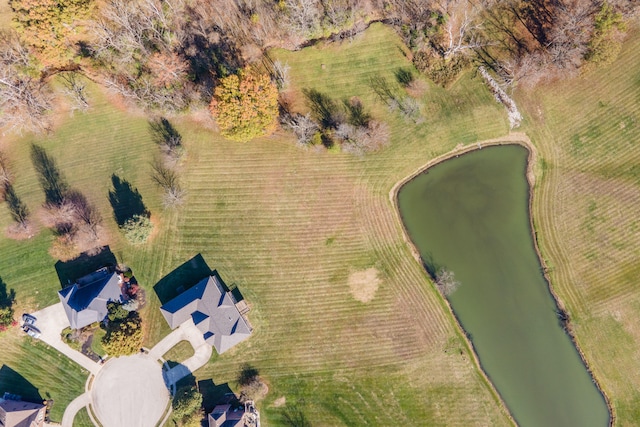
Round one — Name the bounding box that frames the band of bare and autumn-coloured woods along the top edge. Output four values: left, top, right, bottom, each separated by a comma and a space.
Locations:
0, 0, 638, 135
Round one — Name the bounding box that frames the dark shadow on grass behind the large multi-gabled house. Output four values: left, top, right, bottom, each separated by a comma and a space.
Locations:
153, 254, 212, 305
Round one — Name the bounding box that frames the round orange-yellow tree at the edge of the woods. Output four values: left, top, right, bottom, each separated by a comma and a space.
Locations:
210, 70, 278, 141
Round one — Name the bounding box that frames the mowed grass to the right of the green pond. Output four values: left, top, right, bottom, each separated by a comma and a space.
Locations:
517, 27, 640, 425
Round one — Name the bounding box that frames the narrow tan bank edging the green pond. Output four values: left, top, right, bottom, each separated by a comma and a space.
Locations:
389, 132, 616, 426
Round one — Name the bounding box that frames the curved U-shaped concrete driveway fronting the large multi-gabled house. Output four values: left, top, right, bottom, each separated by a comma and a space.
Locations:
149, 319, 212, 388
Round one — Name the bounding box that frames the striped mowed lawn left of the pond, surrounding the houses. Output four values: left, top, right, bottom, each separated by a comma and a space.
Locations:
0, 25, 508, 425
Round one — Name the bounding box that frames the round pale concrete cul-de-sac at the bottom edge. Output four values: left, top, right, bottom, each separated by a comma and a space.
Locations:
91, 354, 169, 427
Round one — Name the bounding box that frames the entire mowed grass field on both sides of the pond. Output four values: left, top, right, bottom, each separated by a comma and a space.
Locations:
0, 18, 640, 426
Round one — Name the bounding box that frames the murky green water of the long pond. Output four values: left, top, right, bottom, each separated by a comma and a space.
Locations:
398, 145, 609, 427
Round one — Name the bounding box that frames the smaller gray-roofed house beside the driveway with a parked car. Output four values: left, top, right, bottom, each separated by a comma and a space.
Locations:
58, 267, 123, 329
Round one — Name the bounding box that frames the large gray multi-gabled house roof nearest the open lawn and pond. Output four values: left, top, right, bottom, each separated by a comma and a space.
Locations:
160, 272, 251, 353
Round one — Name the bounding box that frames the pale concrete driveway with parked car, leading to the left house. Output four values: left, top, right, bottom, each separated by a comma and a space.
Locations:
32, 303, 102, 375
